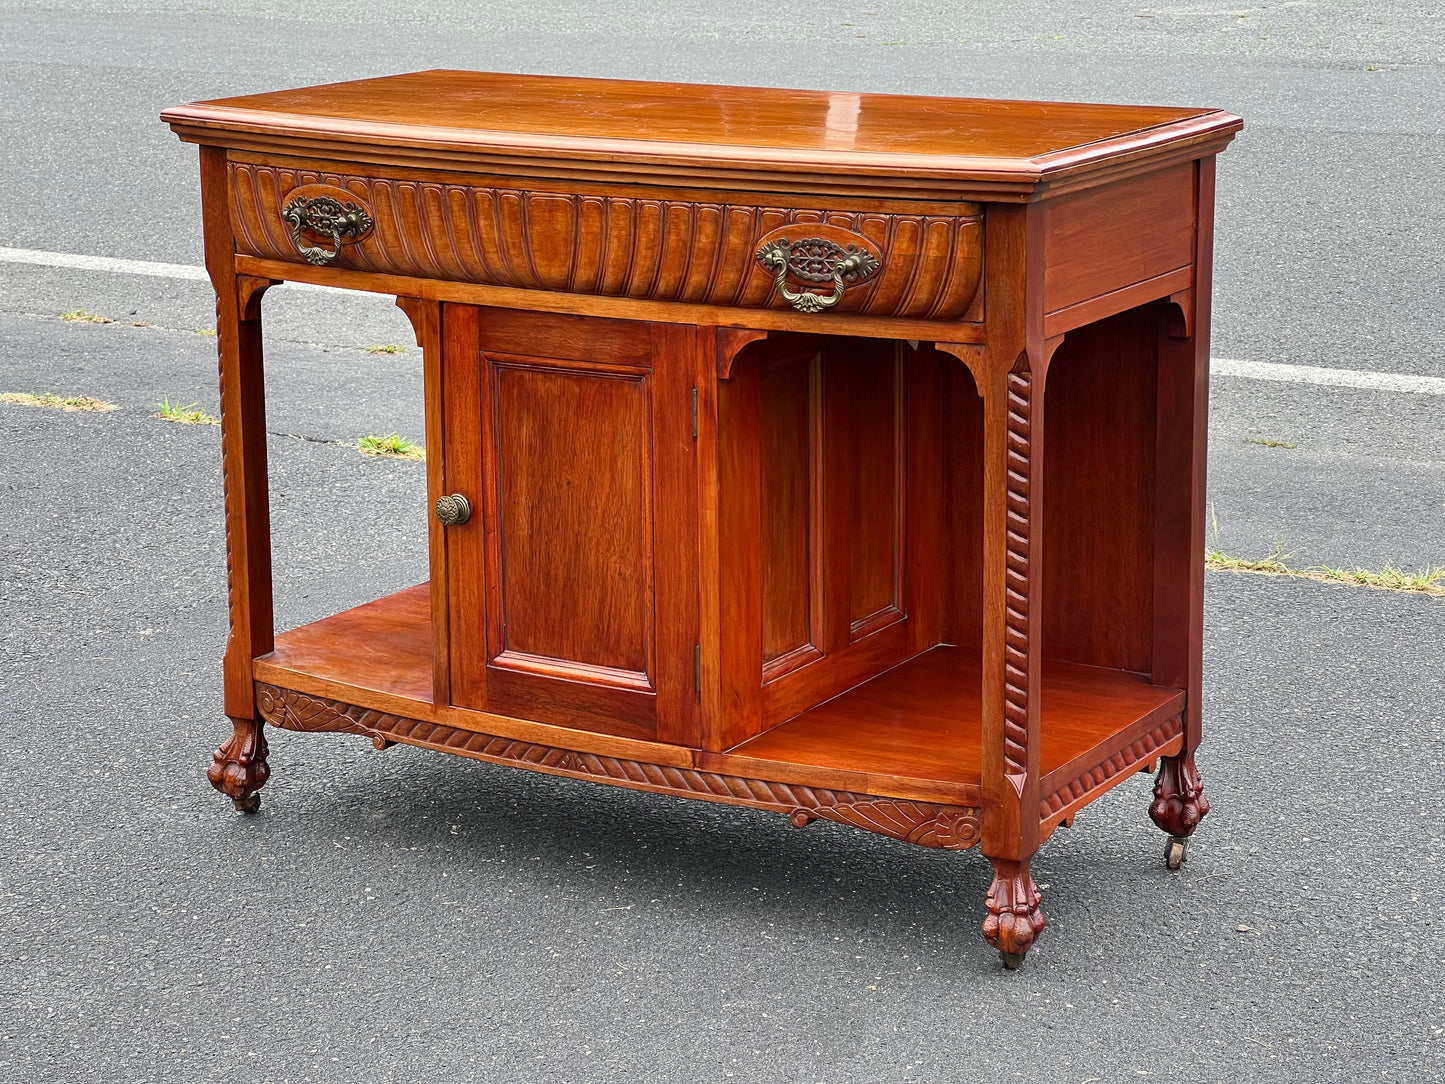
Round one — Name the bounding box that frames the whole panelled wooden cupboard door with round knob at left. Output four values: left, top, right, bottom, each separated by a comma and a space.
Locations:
442, 305, 698, 744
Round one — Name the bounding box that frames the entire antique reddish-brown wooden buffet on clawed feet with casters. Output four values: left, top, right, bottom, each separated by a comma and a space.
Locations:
163, 71, 1241, 967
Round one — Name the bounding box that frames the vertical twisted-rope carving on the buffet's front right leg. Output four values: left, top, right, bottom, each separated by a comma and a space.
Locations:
1003, 371, 1033, 795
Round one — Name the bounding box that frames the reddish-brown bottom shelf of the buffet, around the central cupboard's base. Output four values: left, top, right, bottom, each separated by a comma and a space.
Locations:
256, 584, 1183, 822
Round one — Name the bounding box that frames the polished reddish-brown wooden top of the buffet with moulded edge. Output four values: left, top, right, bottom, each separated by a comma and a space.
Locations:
162, 69, 1241, 187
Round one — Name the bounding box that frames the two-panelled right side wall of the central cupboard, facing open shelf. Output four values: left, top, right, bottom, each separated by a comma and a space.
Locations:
704, 337, 944, 750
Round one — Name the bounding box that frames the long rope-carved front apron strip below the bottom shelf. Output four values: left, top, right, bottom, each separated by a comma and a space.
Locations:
256, 682, 980, 850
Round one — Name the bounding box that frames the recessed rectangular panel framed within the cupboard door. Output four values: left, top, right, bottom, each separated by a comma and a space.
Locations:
487, 356, 653, 689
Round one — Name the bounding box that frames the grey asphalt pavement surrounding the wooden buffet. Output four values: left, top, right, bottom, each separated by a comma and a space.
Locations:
0, 0, 1445, 1084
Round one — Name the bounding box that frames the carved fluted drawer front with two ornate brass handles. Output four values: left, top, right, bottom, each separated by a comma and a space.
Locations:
230, 160, 983, 319
